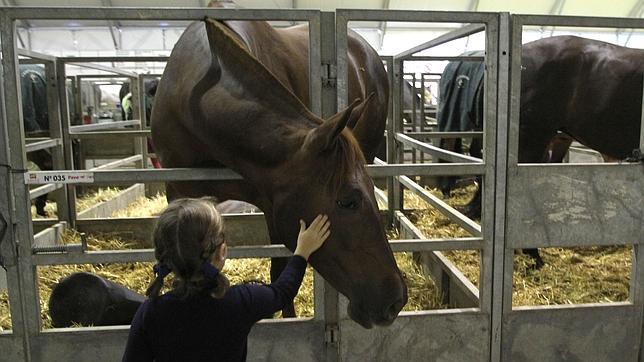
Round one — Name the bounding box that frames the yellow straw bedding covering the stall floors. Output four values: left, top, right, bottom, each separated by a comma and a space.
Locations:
0, 186, 632, 331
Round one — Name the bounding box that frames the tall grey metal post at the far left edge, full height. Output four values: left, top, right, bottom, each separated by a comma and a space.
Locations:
0, 14, 40, 360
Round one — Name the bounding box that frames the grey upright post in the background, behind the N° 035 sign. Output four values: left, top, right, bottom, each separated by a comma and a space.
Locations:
56, 60, 81, 228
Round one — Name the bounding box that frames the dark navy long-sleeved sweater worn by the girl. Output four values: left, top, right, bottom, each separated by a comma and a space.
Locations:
123, 256, 307, 361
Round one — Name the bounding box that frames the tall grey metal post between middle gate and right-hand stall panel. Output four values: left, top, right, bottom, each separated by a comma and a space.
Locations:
490, 13, 513, 361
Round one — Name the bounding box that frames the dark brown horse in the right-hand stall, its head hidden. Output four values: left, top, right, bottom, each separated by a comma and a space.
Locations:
436, 36, 644, 267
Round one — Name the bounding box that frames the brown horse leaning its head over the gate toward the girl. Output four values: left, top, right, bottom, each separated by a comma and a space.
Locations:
152, 20, 407, 328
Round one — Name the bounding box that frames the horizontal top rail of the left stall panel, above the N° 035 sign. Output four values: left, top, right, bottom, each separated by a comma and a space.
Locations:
2, 6, 319, 21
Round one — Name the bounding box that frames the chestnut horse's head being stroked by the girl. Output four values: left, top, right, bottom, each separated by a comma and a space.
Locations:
270, 100, 407, 328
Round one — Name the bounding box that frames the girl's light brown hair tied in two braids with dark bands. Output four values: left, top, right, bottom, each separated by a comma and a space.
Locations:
145, 198, 230, 299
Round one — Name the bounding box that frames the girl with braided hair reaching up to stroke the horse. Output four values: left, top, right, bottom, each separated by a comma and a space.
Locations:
123, 198, 330, 361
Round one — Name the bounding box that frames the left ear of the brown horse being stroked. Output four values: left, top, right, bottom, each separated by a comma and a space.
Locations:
303, 99, 362, 154
